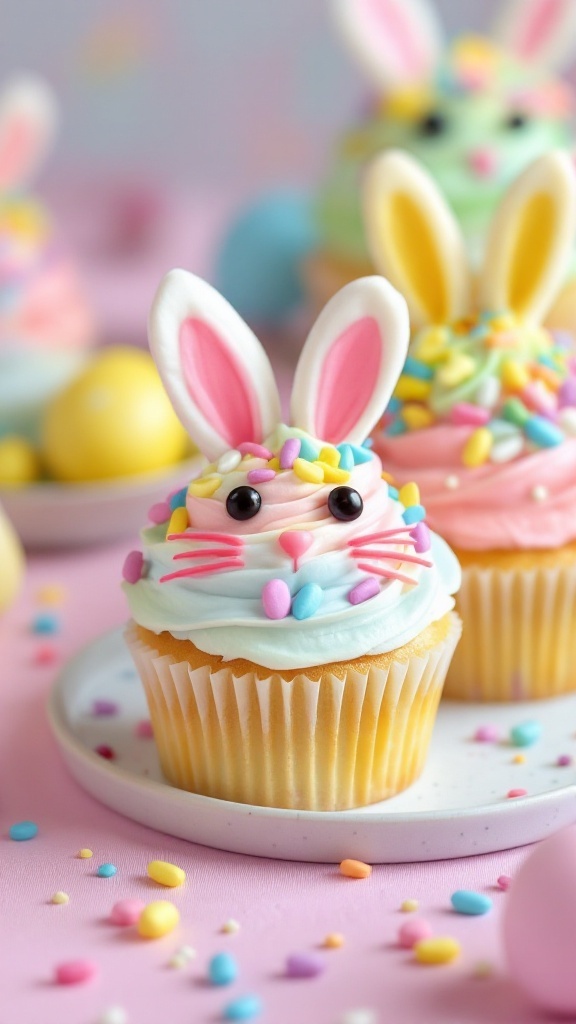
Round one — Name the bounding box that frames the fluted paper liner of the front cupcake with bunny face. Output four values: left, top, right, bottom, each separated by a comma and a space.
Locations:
126, 614, 461, 810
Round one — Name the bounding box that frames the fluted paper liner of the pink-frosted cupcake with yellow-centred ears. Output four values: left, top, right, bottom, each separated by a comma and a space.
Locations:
444, 564, 576, 700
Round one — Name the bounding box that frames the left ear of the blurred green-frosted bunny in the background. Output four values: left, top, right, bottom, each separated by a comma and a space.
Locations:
332, 0, 443, 89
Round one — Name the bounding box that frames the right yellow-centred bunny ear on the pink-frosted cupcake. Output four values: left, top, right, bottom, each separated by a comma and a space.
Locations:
480, 151, 576, 324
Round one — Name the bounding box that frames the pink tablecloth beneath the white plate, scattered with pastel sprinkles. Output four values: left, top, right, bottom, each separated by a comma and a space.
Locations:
0, 545, 549, 1024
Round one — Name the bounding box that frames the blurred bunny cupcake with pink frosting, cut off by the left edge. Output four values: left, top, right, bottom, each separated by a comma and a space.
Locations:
0, 78, 92, 436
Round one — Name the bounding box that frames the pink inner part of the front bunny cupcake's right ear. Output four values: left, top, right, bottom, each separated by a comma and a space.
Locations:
316, 316, 383, 444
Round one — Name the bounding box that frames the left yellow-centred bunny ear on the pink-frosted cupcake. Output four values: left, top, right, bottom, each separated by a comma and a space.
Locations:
363, 150, 470, 327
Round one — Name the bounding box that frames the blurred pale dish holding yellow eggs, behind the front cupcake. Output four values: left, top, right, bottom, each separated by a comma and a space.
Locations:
0, 456, 205, 548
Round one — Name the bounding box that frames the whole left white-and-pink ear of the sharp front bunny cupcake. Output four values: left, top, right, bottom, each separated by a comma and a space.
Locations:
149, 270, 280, 461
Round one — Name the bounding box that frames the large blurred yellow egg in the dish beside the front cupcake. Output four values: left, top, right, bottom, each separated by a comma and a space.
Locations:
41, 347, 190, 482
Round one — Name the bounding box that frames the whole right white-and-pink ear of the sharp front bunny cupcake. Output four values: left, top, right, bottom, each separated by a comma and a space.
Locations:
291, 276, 410, 444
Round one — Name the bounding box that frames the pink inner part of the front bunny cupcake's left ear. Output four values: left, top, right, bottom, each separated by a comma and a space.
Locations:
179, 316, 263, 447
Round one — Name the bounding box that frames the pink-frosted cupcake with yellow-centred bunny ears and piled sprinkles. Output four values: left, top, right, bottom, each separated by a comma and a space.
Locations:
365, 146, 576, 700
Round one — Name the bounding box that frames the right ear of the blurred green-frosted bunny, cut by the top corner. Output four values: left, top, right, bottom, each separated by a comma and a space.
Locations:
492, 0, 576, 68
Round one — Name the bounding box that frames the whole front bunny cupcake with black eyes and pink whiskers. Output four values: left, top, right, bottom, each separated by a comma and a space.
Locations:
123, 270, 459, 810
